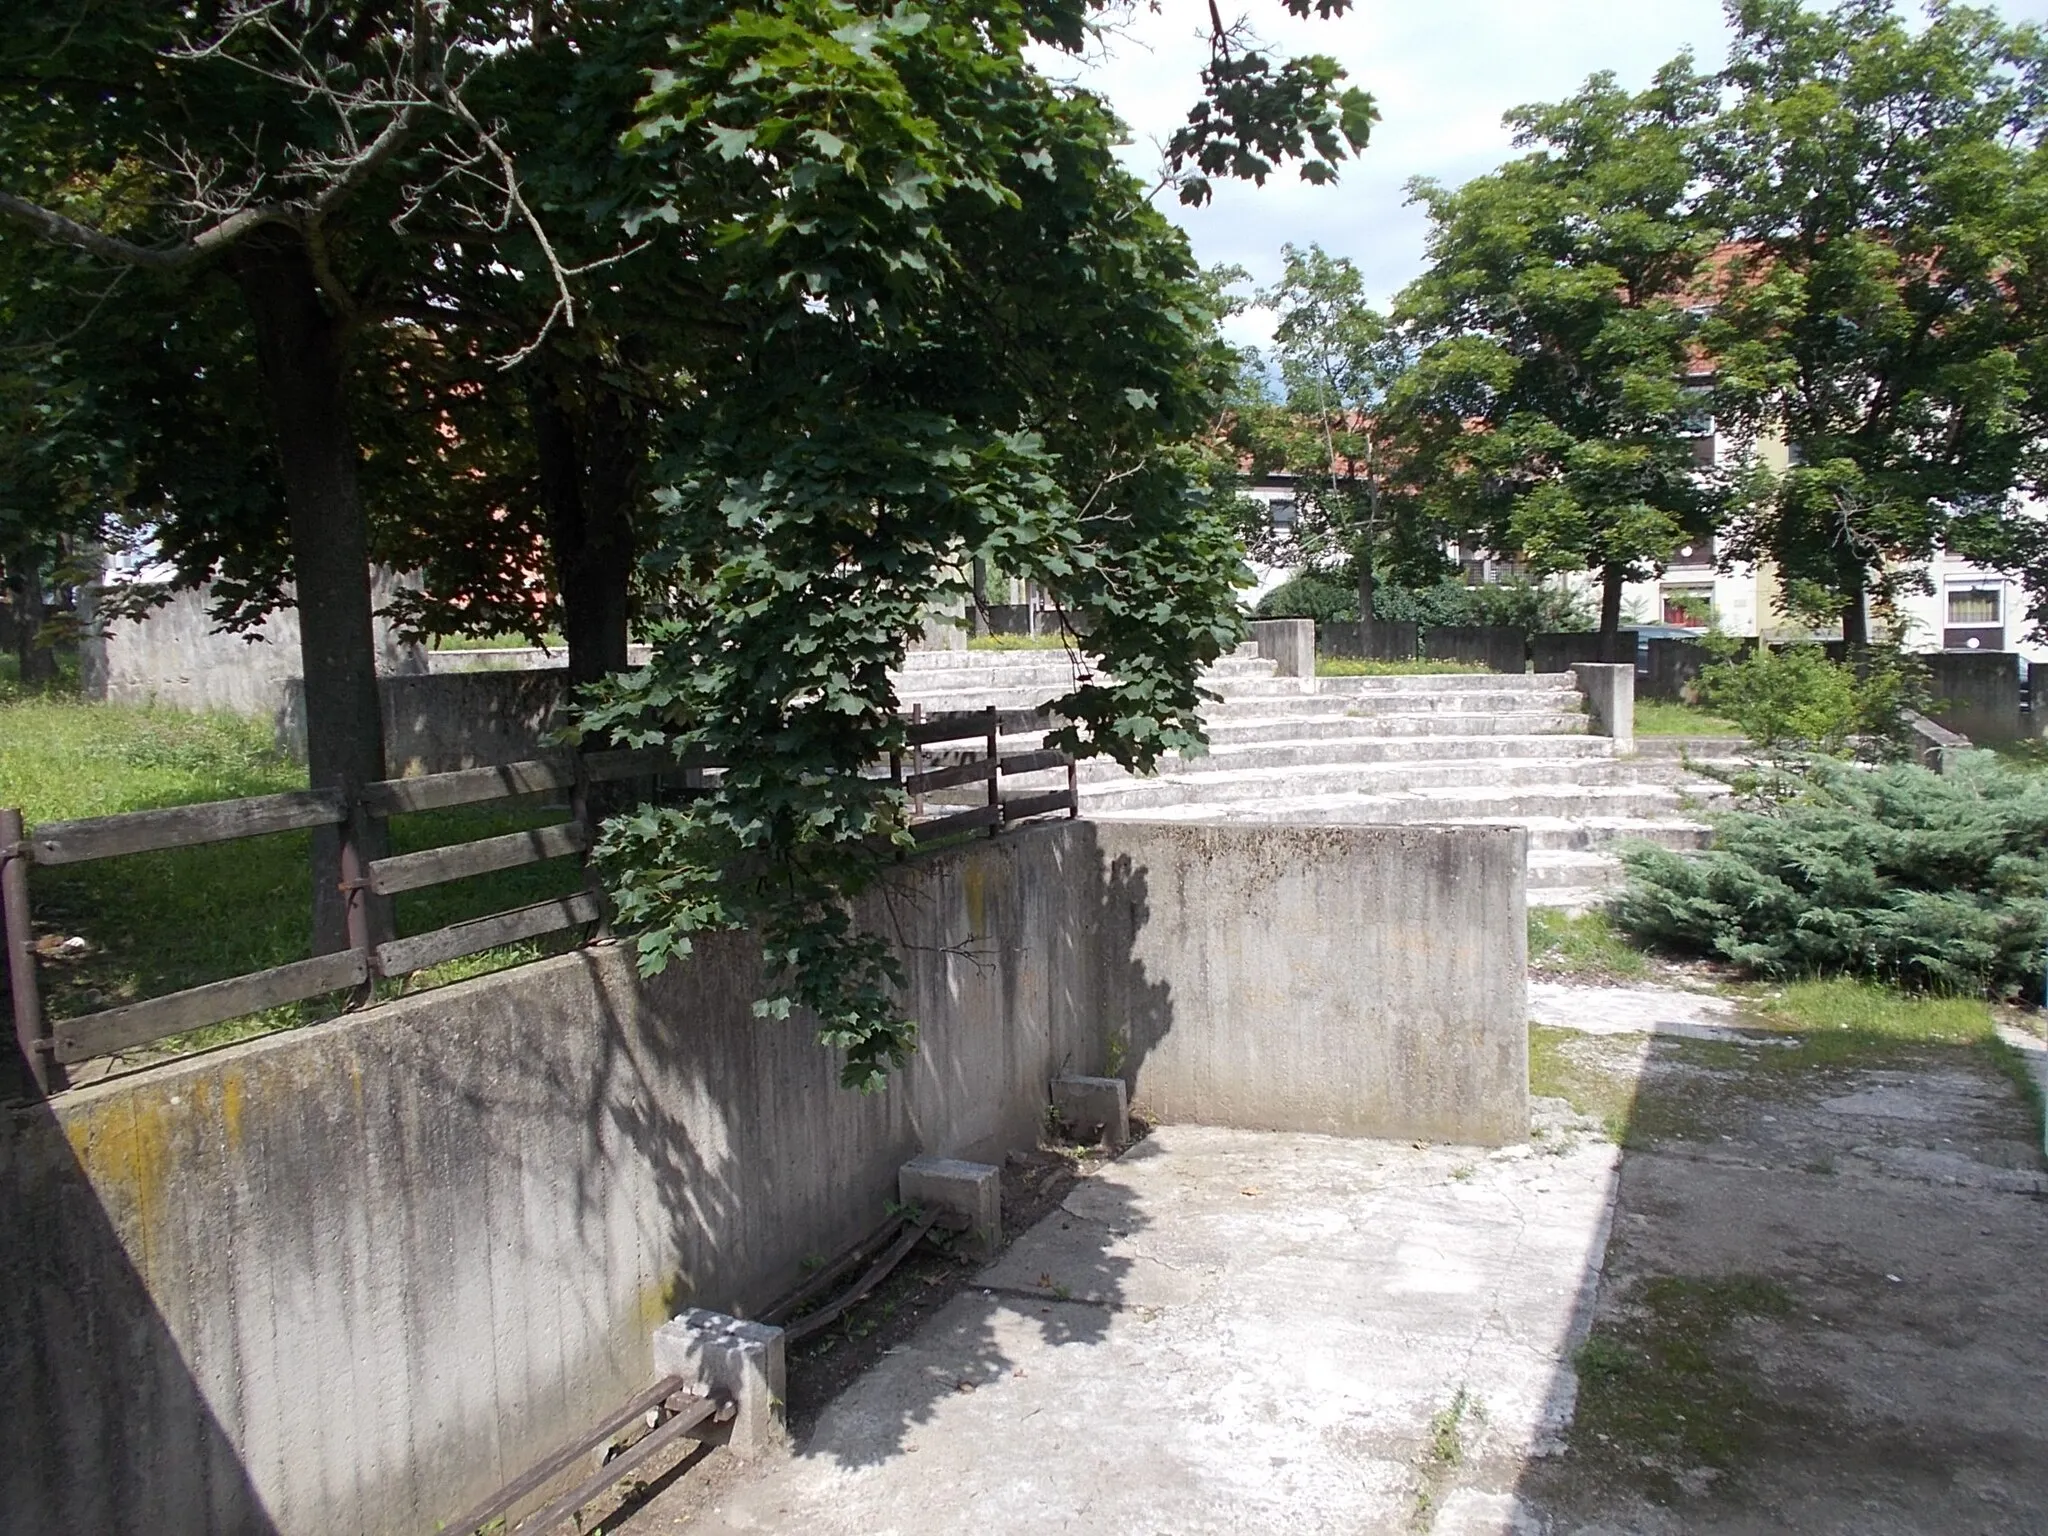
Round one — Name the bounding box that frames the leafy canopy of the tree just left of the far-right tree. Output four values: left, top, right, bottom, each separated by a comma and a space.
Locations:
1397, 57, 1714, 631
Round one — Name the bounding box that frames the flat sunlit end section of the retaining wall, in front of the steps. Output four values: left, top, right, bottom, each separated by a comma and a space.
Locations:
1092, 821, 1528, 1145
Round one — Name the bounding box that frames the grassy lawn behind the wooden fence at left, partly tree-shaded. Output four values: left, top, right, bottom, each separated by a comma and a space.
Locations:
0, 698, 582, 1053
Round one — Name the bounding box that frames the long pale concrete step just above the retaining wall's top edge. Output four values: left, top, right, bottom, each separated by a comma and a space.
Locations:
1081, 780, 1688, 825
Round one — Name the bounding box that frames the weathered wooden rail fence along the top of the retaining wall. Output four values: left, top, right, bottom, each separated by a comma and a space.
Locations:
0, 709, 1079, 1094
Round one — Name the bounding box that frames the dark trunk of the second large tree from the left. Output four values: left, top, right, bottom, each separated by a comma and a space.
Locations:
530, 360, 641, 688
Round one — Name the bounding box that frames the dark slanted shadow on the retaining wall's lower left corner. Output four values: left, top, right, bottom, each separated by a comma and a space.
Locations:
0, 1104, 282, 1536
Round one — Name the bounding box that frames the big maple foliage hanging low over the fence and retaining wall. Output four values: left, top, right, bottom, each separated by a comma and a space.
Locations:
584, 0, 1359, 1090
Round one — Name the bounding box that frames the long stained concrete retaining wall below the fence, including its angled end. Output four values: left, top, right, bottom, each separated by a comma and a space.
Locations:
0, 821, 1528, 1536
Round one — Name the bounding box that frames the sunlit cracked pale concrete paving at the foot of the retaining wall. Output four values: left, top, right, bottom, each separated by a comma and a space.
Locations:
694, 1126, 1616, 1536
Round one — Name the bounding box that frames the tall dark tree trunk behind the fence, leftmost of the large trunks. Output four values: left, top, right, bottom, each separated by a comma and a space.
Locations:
233, 233, 389, 954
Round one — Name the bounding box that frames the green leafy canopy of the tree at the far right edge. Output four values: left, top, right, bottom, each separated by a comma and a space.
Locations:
1704, 0, 2048, 641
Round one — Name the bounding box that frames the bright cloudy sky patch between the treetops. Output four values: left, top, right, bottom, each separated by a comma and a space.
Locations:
1040, 0, 2048, 344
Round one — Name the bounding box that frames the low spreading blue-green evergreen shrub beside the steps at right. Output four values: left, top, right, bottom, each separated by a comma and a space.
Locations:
1614, 752, 2048, 995
